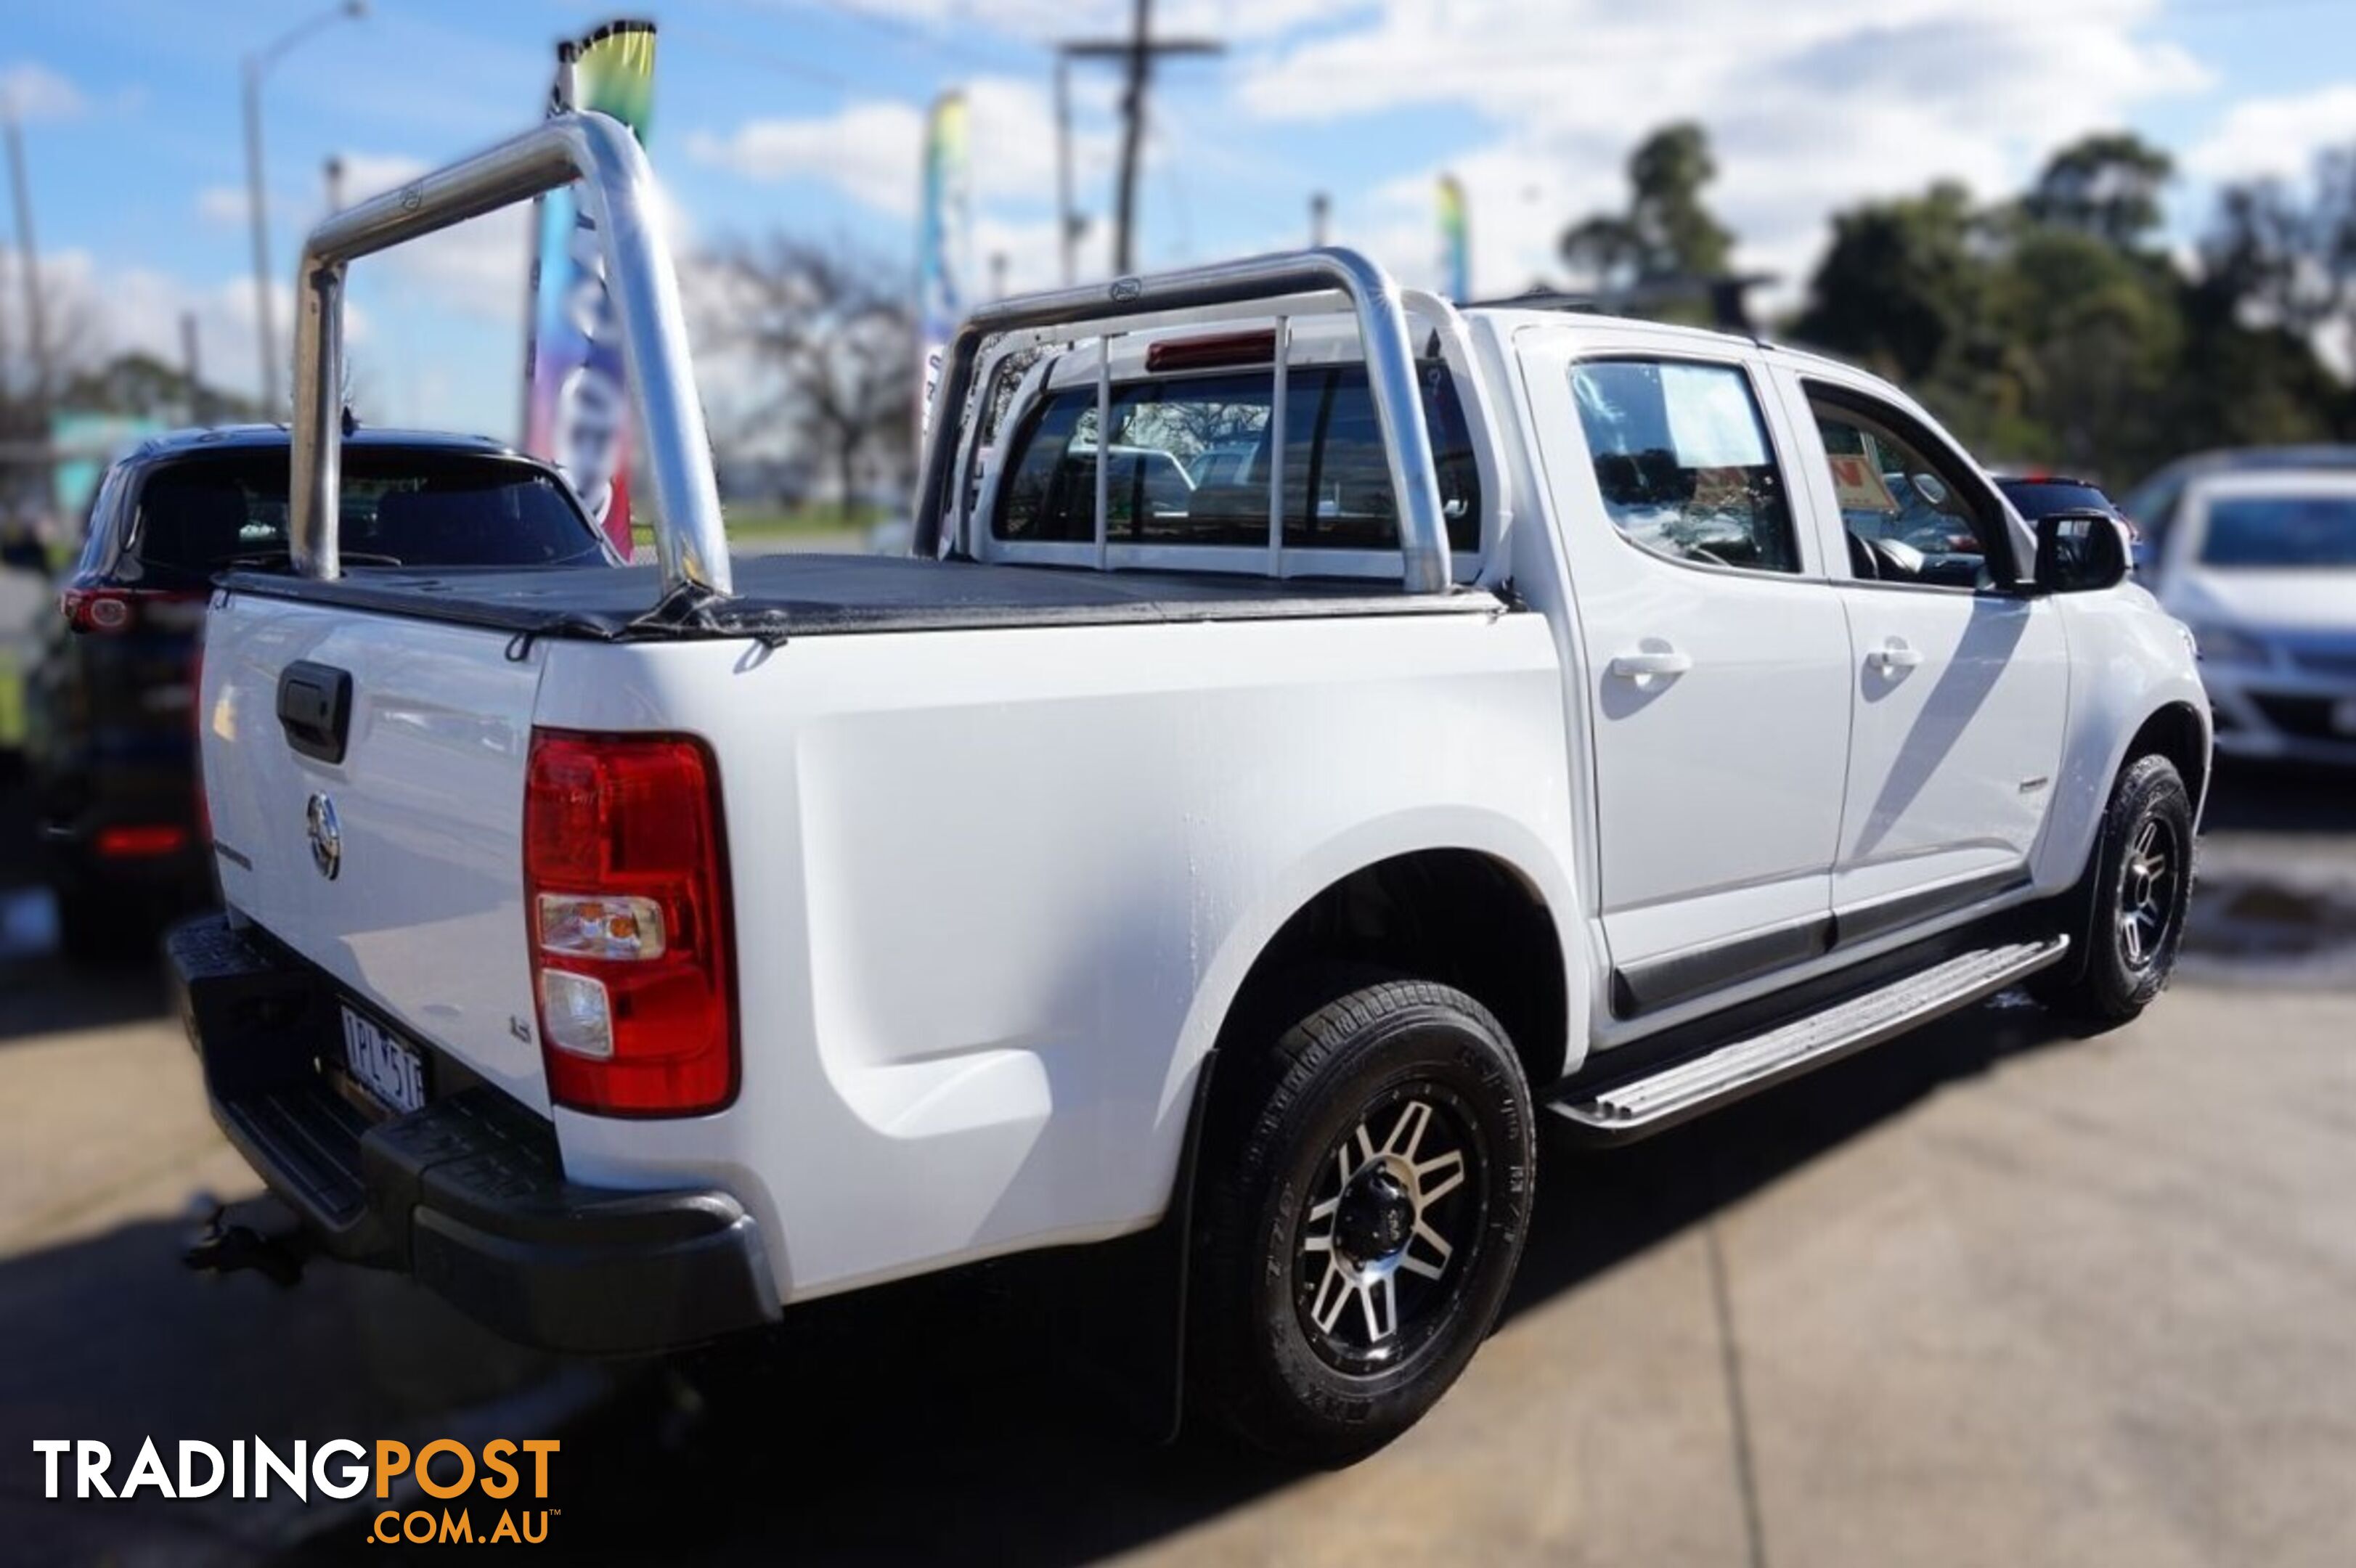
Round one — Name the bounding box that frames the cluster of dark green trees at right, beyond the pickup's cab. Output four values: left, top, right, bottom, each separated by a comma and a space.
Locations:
1790, 134, 2356, 485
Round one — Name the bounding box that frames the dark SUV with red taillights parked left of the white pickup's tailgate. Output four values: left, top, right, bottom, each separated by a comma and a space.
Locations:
26, 426, 610, 956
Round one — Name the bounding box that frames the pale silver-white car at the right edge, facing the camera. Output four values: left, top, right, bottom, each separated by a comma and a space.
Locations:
2161, 468, 2356, 765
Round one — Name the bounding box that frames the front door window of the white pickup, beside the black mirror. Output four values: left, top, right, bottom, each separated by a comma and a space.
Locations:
1807, 386, 2005, 593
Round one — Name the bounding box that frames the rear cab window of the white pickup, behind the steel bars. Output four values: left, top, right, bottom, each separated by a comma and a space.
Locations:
990, 362, 1480, 551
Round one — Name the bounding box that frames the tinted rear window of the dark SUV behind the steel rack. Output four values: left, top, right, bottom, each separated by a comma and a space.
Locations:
125, 447, 606, 584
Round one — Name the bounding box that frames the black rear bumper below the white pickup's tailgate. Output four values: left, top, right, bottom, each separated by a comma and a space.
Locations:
165, 913, 778, 1354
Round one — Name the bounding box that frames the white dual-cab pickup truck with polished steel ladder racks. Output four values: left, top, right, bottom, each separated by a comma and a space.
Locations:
170, 113, 2210, 1460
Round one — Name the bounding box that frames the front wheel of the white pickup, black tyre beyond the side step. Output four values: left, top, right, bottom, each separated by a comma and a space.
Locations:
2031, 756, 2193, 1024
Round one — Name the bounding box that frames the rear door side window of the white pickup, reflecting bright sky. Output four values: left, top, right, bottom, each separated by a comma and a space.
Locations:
1571, 360, 1800, 572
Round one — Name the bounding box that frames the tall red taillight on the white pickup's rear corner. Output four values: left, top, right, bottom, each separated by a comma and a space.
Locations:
523, 730, 738, 1116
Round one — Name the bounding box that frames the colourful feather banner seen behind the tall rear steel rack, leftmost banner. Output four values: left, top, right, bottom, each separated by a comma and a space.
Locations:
523, 21, 655, 555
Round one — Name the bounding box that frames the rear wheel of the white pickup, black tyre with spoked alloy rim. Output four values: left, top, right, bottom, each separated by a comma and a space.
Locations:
1187, 979, 1536, 1464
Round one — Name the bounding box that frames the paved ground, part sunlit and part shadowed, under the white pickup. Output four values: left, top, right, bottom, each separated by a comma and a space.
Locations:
0, 770, 2356, 1568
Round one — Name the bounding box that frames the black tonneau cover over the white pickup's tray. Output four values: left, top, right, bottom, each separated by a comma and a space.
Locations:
221, 553, 1503, 642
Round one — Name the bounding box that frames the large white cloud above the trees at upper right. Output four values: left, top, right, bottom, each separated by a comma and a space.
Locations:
1234, 0, 2210, 292
